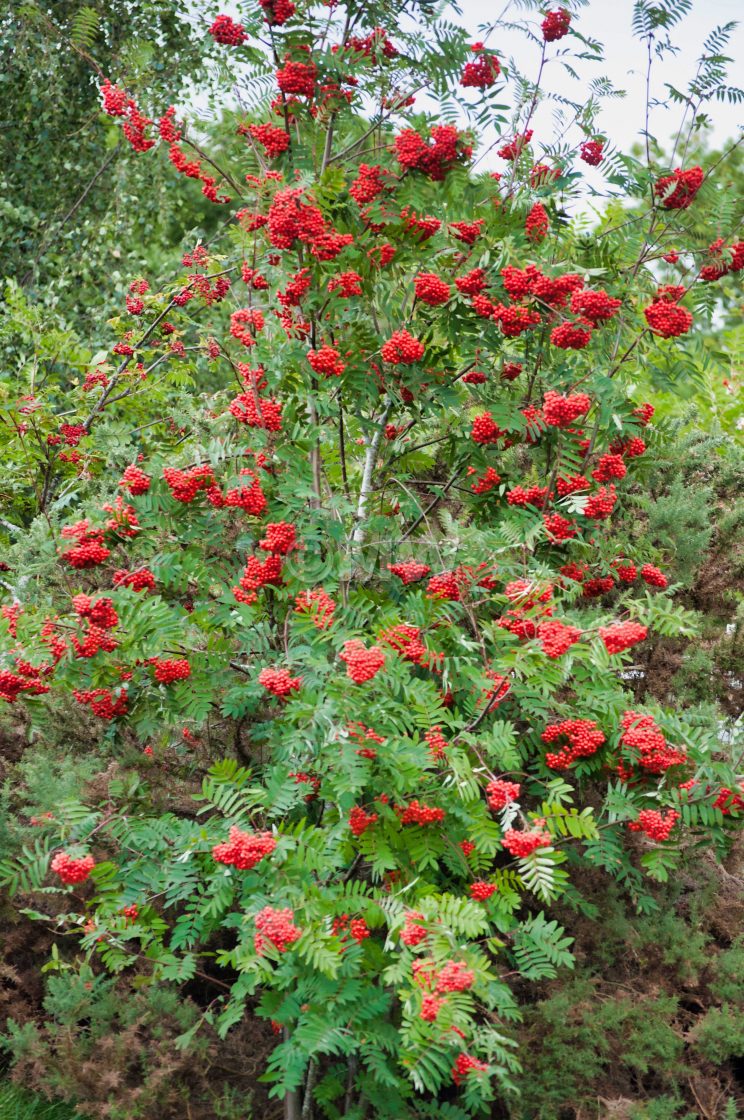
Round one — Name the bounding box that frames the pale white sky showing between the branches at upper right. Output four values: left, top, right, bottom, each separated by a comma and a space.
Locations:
453, 0, 744, 156
